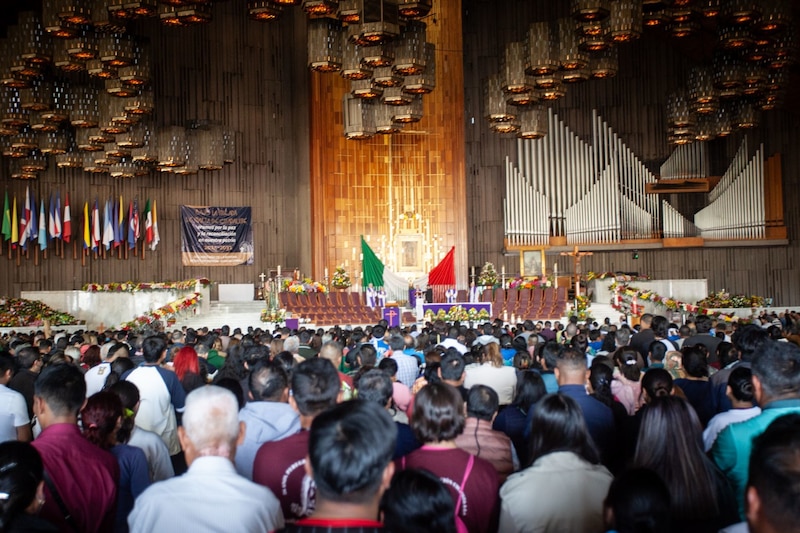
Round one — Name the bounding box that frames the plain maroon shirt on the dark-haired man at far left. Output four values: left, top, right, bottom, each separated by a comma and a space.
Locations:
33, 424, 119, 533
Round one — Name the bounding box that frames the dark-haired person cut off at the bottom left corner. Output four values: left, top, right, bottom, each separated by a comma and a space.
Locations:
0, 440, 58, 533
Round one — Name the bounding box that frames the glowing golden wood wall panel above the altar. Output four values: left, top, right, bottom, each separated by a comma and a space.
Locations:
311, 0, 467, 286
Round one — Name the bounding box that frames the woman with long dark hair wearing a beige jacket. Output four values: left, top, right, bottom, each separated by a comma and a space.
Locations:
499, 394, 613, 533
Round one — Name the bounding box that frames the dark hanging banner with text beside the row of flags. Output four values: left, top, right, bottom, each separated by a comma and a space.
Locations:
181, 205, 253, 266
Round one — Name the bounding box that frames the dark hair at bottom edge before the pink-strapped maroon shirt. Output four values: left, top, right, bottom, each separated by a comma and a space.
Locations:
381, 468, 456, 533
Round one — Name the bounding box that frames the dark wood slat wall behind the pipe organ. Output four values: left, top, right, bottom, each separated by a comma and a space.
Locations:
463, 0, 800, 305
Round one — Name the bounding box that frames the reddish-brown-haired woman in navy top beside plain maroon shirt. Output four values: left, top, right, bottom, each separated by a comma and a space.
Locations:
81, 391, 150, 531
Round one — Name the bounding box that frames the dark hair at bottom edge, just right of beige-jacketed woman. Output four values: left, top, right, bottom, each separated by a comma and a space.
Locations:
605, 468, 672, 533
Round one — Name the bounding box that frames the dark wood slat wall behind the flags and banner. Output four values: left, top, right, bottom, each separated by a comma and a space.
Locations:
0, 2, 310, 295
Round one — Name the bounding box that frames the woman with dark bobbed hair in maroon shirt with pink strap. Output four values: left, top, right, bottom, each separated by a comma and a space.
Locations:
404, 382, 496, 533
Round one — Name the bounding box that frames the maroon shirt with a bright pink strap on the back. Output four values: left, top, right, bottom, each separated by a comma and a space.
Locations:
397, 446, 500, 533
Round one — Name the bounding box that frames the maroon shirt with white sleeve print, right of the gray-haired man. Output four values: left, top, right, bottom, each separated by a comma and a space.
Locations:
253, 430, 317, 521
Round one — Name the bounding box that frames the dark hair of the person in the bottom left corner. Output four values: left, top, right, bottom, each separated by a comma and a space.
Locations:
0, 440, 43, 531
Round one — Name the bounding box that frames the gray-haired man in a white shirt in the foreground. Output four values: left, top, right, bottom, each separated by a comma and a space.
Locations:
128, 386, 284, 533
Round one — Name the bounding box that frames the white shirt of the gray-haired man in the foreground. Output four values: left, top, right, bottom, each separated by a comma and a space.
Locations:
128, 457, 284, 533
